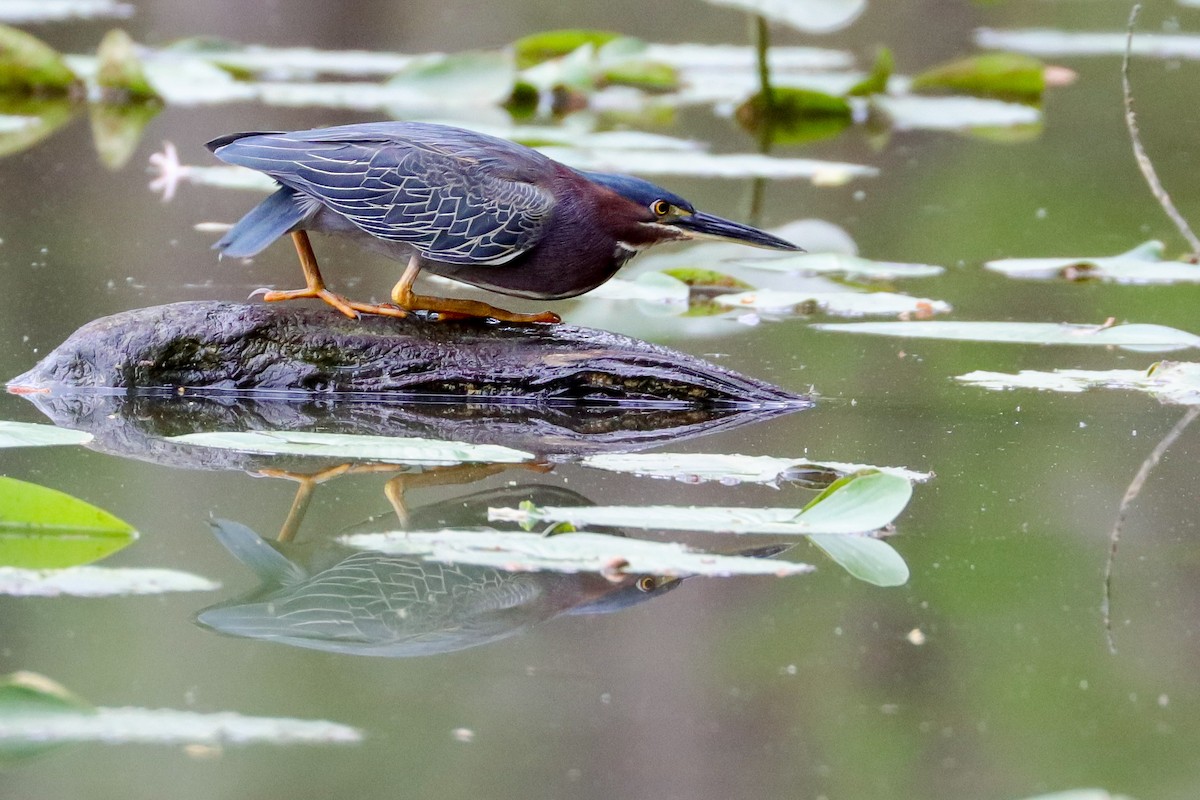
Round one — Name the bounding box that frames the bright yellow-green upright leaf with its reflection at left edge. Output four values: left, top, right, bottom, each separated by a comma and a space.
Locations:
0, 477, 137, 569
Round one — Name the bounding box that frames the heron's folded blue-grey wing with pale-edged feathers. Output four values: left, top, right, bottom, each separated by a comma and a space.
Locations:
217, 126, 554, 264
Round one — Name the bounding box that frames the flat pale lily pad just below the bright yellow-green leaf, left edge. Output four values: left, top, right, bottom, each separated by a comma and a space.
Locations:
0, 566, 221, 597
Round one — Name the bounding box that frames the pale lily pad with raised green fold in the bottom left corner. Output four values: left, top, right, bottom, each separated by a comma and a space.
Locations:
0, 673, 362, 757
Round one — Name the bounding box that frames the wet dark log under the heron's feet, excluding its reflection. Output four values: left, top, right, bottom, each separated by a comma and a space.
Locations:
8, 302, 810, 409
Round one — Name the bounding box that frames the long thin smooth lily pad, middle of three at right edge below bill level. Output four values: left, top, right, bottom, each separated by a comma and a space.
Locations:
812, 321, 1200, 353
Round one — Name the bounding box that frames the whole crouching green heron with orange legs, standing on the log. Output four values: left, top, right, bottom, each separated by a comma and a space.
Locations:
208, 122, 799, 323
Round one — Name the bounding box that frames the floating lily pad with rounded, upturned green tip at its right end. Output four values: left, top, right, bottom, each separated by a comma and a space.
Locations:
488, 473, 912, 535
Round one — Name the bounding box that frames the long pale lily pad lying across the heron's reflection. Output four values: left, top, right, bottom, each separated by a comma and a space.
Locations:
341, 529, 812, 577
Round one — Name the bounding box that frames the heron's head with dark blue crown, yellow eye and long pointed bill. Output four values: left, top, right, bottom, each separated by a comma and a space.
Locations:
581, 173, 800, 251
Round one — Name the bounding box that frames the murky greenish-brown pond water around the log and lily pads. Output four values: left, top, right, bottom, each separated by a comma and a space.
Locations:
0, 0, 1200, 800
